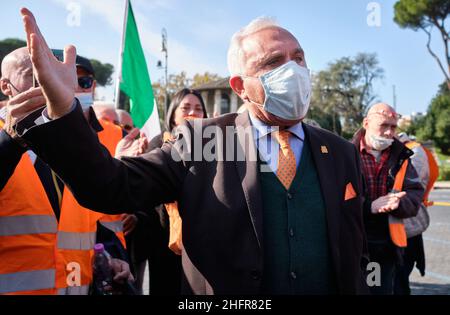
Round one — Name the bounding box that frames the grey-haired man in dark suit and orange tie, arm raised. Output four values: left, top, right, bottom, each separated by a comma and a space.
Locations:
7, 9, 368, 294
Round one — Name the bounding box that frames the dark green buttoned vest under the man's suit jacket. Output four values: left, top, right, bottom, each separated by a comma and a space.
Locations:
260, 141, 336, 294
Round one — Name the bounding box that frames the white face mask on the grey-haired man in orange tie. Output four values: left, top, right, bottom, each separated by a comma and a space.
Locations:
244, 61, 311, 120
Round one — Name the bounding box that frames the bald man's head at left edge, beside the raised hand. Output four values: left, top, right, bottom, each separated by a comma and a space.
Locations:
0, 47, 33, 97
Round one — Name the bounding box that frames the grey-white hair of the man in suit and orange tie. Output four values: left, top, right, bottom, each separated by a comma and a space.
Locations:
227, 16, 282, 76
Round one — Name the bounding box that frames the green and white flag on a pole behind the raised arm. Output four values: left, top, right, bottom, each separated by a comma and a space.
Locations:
116, 0, 161, 139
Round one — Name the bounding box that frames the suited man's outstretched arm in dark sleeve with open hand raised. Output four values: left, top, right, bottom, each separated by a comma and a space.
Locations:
8, 9, 188, 213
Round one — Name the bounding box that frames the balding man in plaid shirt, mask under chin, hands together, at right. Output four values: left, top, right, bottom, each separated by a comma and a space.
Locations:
353, 103, 424, 294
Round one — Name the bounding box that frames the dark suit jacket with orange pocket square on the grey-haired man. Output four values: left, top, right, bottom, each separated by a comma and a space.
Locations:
24, 106, 367, 294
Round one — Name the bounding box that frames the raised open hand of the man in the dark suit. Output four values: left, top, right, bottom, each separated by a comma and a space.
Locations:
20, 8, 77, 119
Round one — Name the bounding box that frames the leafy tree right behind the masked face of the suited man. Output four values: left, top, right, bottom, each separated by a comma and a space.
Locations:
311, 53, 384, 136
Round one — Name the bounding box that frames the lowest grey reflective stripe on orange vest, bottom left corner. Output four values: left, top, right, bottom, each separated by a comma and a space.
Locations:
0, 269, 55, 294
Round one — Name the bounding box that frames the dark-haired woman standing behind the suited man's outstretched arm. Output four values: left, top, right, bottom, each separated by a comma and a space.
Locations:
128, 89, 207, 295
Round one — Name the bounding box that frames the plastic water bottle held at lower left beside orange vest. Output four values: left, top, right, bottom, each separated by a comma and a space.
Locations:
93, 243, 113, 295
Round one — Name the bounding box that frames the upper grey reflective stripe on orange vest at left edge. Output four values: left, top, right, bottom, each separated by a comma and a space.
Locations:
0, 215, 58, 236
